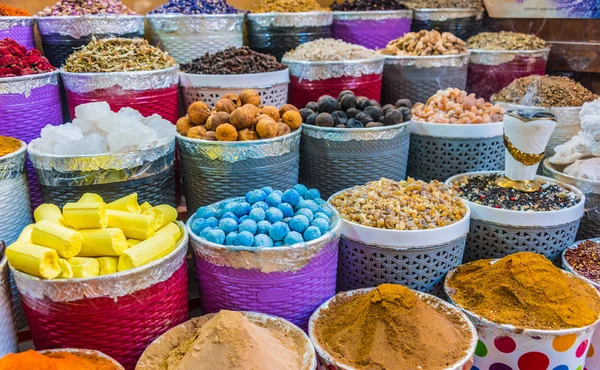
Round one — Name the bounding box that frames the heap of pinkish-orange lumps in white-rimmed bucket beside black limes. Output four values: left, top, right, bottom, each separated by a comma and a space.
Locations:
412, 87, 504, 124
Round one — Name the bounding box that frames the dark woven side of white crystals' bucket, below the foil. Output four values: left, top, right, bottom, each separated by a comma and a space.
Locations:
40, 165, 175, 207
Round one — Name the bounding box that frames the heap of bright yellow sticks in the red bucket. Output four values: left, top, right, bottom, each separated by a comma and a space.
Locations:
6, 193, 183, 279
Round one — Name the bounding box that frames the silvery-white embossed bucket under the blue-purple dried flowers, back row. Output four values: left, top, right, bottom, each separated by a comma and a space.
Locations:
146, 14, 244, 64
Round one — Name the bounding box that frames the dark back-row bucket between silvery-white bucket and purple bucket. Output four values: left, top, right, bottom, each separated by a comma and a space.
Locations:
246, 11, 333, 60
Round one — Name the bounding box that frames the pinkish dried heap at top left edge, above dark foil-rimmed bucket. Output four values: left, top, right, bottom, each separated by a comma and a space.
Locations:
37, 0, 136, 17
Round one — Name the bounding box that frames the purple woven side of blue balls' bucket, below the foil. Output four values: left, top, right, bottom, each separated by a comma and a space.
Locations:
192, 239, 338, 331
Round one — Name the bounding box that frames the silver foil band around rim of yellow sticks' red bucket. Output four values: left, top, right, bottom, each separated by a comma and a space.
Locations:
10, 221, 188, 309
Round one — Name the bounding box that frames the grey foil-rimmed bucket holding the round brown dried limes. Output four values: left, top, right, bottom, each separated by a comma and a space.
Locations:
177, 127, 302, 214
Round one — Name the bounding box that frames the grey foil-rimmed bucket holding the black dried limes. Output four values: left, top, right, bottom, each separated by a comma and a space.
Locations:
300, 121, 411, 197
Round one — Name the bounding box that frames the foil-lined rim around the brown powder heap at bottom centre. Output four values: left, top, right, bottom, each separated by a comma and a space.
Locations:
308, 288, 476, 370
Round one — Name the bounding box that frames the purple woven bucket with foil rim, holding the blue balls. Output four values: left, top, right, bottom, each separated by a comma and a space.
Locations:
187, 198, 341, 331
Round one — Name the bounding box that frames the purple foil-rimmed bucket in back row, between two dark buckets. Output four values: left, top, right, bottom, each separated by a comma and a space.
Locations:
331, 10, 412, 49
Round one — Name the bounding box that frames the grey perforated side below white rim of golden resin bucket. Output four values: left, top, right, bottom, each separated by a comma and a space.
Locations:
338, 235, 467, 297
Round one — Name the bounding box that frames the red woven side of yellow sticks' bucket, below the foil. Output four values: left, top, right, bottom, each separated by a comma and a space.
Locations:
21, 261, 188, 370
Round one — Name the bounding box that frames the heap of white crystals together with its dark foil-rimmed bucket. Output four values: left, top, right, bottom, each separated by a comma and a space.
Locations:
28, 102, 176, 206
